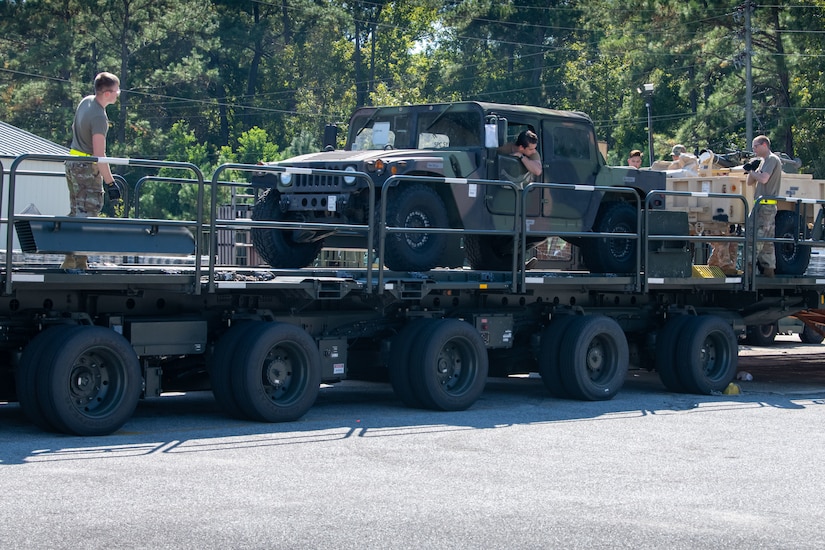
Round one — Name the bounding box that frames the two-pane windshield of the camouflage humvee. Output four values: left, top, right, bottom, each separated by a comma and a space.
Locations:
349, 104, 484, 151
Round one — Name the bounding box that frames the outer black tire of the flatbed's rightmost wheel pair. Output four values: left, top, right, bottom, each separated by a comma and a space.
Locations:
676, 315, 739, 395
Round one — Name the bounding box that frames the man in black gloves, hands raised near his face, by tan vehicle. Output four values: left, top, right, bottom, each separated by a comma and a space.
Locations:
745, 136, 782, 277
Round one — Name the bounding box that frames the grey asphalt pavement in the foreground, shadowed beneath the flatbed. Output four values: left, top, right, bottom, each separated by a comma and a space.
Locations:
0, 337, 825, 549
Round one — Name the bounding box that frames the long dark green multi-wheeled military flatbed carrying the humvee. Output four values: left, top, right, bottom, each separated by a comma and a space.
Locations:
0, 157, 825, 435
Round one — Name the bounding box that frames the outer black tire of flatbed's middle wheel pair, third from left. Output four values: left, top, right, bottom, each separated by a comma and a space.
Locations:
410, 319, 489, 411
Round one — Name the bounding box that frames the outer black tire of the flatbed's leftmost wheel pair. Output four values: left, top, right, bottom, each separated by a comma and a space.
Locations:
38, 326, 143, 436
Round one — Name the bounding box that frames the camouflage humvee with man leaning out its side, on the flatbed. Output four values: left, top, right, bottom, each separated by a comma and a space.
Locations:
252, 101, 665, 273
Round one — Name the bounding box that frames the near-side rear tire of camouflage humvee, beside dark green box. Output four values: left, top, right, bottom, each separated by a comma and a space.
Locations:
581, 201, 637, 273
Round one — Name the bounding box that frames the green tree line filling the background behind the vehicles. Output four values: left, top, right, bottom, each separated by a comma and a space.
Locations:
0, 0, 825, 178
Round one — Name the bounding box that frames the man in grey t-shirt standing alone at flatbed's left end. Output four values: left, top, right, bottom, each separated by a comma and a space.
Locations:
60, 72, 120, 270
